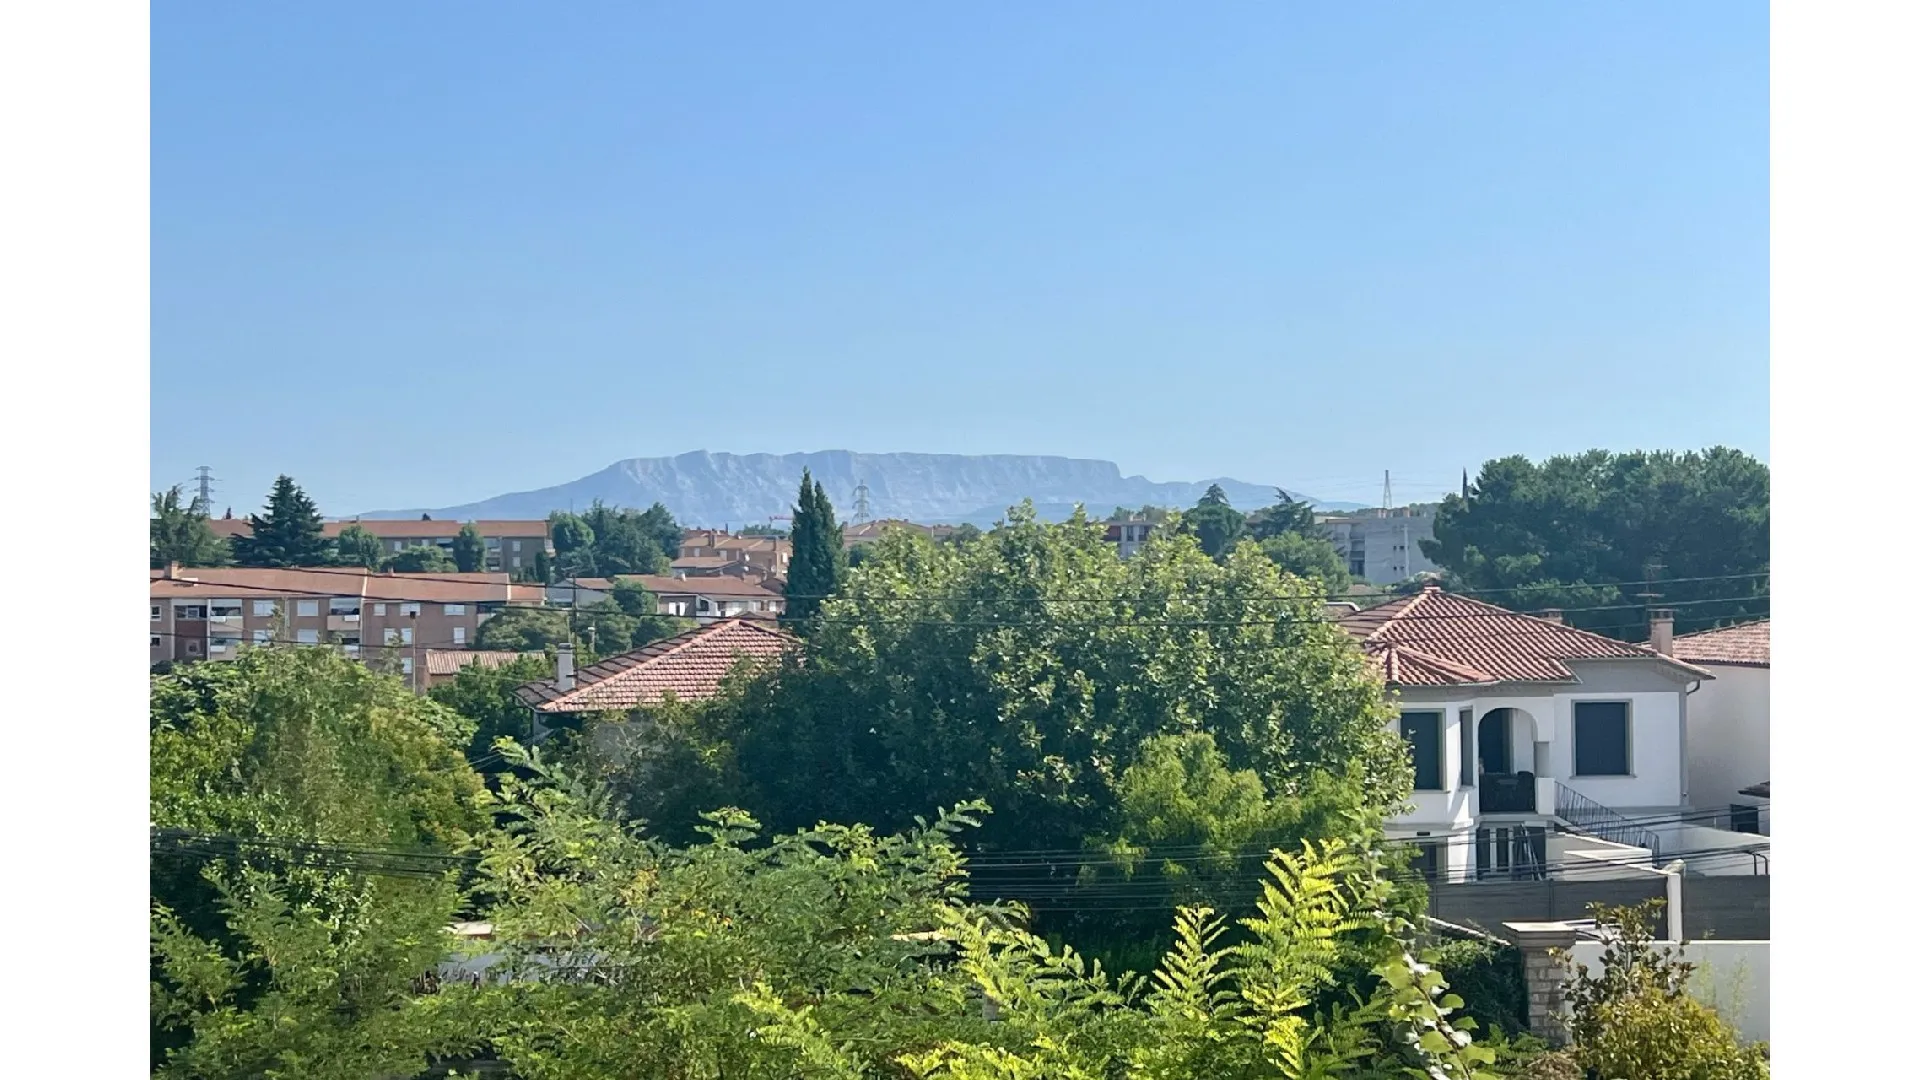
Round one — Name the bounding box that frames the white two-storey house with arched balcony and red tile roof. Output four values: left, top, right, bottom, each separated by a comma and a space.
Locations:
1340, 586, 1713, 880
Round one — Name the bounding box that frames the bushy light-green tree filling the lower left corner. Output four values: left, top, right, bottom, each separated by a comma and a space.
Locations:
150, 650, 488, 1080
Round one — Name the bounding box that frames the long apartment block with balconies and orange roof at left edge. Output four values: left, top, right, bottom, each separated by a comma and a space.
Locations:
148, 567, 543, 676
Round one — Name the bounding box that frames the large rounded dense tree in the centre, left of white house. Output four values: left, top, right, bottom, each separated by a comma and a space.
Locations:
660, 509, 1411, 849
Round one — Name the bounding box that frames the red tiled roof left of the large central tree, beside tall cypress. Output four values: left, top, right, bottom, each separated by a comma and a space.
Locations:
516, 619, 799, 713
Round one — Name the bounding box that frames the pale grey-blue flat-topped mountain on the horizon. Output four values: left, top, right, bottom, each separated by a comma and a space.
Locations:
361, 450, 1359, 528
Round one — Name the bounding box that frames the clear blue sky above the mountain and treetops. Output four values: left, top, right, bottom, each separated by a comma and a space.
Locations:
152, 0, 1768, 513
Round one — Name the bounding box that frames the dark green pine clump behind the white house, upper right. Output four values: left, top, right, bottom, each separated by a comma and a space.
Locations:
1421, 446, 1770, 636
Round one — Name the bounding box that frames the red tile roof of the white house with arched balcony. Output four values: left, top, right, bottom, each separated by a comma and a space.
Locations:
1340, 586, 1711, 686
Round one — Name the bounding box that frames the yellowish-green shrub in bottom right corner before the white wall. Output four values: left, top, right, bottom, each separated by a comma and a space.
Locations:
1567, 901, 1768, 1080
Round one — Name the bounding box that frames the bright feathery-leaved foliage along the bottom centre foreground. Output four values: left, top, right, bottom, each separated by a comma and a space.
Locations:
444, 755, 1490, 1080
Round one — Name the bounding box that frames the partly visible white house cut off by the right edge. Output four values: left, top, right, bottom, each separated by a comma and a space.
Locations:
1672, 619, 1772, 834
